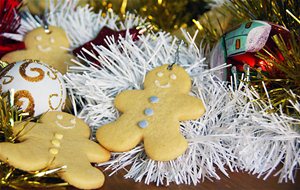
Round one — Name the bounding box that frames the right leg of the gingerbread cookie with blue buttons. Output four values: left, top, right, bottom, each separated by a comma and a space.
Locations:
144, 121, 188, 161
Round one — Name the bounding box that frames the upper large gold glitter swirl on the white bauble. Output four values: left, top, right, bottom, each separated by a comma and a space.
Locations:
19, 60, 45, 82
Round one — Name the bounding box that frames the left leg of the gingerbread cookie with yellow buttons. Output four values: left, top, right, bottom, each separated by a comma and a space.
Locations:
0, 140, 51, 171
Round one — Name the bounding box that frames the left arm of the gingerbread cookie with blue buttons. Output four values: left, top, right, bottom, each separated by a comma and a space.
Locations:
114, 90, 143, 113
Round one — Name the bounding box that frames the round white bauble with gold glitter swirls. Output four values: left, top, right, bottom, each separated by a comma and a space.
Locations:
0, 60, 66, 116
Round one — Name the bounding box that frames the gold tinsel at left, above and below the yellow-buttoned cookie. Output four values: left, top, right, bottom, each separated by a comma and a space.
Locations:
0, 93, 68, 189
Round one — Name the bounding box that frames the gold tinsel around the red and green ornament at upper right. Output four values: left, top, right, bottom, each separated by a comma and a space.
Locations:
190, 0, 300, 118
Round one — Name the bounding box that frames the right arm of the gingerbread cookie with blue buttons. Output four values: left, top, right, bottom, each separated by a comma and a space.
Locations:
177, 94, 205, 121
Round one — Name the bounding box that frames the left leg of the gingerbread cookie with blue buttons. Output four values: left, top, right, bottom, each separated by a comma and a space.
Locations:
96, 114, 143, 152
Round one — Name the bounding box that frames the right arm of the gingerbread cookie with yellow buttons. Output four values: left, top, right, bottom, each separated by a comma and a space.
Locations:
84, 140, 110, 163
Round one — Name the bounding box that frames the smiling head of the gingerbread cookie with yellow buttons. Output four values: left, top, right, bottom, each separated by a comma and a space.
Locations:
40, 111, 90, 137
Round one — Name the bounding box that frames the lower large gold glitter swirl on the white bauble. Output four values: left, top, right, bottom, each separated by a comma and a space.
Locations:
14, 90, 35, 116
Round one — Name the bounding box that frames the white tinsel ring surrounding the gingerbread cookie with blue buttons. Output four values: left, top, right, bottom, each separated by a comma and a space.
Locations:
66, 29, 239, 185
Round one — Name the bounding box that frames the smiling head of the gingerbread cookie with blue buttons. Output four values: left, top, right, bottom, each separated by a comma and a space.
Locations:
144, 64, 191, 93
